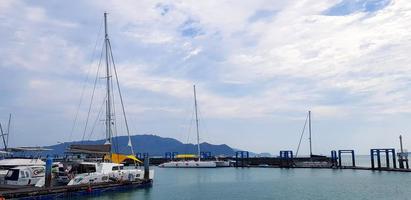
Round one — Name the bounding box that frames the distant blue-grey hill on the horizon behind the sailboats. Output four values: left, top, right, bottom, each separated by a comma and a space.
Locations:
43, 135, 235, 156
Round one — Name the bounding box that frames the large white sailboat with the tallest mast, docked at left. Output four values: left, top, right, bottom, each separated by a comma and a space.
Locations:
68, 13, 154, 185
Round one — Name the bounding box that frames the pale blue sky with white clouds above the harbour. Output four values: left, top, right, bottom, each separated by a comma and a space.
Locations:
0, 0, 411, 155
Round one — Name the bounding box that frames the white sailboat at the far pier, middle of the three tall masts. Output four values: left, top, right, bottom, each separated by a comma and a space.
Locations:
159, 85, 217, 168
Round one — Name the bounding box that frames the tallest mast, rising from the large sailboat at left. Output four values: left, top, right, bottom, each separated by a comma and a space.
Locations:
104, 13, 112, 144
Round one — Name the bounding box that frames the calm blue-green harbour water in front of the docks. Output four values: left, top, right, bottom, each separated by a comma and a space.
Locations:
79, 168, 411, 200
